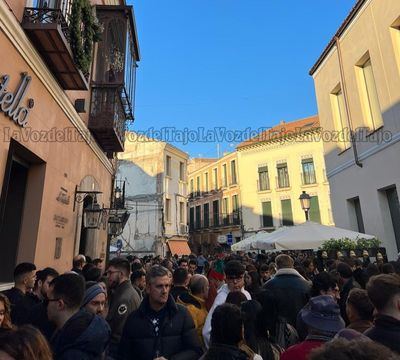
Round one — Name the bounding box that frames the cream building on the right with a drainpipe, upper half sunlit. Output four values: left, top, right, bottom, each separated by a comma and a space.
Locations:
310, 0, 400, 259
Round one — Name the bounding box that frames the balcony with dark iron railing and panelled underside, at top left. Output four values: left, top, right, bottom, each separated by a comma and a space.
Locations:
22, 1, 88, 90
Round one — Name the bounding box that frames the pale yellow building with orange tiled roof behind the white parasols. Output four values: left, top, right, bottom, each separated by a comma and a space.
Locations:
237, 116, 333, 236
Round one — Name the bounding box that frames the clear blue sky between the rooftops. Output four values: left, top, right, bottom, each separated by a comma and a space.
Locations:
130, 0, 355, 157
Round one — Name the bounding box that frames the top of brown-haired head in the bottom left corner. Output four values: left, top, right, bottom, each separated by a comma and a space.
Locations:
0, 325, 53, 360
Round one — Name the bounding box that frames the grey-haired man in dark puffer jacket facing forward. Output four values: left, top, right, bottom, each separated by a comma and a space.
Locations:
118, 265, 202, 360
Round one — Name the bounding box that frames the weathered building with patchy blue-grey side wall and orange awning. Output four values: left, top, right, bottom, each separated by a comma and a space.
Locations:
117, 132, 190, 256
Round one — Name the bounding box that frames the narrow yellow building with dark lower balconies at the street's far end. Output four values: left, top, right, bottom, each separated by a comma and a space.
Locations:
188, 152, 243, 253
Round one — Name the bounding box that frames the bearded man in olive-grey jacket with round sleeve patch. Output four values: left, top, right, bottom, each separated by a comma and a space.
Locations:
106, 258, 141, 357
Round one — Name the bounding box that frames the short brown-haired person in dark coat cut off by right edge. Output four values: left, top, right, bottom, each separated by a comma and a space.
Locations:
364, 274, 400, 354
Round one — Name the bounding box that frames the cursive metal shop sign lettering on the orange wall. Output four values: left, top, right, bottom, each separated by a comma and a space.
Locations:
0, 73, 34, 127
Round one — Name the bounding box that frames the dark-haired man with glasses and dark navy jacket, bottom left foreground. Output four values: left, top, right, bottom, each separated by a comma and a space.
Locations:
47, 273, 111, 360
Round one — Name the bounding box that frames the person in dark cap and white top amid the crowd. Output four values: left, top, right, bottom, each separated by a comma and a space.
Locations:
203, 260, 251, 348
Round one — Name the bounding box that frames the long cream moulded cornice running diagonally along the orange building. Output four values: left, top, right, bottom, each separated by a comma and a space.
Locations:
0, 0, 114, 174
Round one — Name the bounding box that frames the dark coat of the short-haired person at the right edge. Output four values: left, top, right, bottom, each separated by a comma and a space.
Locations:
364, 315, 400, 354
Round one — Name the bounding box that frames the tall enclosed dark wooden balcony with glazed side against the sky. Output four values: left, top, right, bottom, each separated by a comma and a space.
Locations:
88, 5, 140, 153
